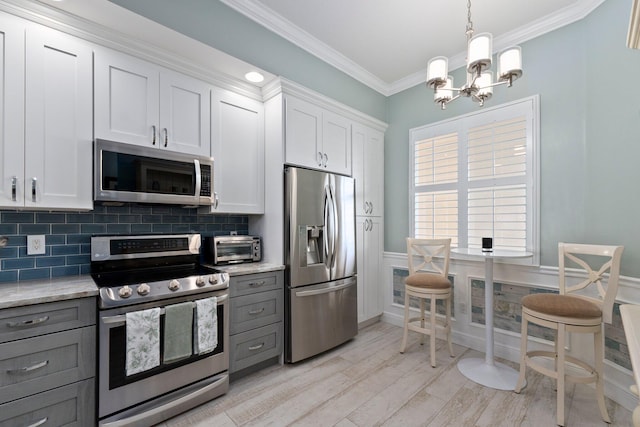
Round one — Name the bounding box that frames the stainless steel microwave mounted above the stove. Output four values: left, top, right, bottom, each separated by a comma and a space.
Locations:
93, 139, 213, 206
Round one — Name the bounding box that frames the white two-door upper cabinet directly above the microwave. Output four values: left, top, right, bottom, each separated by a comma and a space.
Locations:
94, 48, 211, 156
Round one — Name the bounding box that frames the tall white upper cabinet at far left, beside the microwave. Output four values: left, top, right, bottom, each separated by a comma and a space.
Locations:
0, 15, 93, 210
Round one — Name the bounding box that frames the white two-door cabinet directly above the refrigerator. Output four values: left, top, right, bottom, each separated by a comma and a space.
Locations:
285, 96, 351, 175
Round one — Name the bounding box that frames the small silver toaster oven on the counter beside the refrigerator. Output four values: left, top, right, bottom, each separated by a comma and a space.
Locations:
205, 236, 262, 265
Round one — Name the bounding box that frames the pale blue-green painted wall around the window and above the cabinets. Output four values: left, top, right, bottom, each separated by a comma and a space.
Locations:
111, 0, 640, 277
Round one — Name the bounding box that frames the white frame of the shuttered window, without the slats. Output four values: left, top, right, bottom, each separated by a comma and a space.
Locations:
408, 95, 540, 265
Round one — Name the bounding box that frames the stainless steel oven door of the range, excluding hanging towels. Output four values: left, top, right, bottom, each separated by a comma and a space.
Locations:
98, 289, 229, 419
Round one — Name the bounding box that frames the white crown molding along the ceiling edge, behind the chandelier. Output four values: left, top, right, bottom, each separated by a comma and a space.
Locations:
220, 0, 604, 96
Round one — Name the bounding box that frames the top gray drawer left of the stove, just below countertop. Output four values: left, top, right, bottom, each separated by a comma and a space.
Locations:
0, 298, 96, 343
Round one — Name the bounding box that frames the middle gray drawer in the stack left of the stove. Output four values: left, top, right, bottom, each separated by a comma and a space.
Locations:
0, 326, 96, 403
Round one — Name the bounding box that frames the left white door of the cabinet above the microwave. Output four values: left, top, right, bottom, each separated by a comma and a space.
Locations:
94, 49, 160, 146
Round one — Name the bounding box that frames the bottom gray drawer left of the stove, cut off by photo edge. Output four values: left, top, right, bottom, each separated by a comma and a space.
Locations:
0, 379, 95, 427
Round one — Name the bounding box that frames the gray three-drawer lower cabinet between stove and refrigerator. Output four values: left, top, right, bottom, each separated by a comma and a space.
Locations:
229, 271, 284, 374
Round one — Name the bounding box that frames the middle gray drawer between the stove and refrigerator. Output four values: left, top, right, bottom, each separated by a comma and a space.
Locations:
229, 290, 284, 335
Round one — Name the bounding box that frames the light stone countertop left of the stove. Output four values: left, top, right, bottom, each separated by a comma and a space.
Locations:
0, 275, 98, 309
